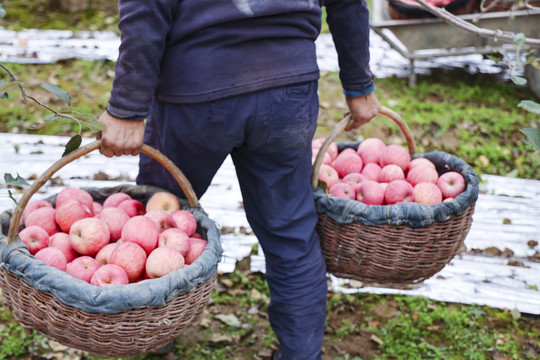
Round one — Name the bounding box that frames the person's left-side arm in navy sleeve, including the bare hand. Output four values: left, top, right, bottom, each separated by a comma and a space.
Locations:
98, 0, 178, 157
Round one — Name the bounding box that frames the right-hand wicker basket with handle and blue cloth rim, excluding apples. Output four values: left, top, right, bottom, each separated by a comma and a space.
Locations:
312, 107, 478, 287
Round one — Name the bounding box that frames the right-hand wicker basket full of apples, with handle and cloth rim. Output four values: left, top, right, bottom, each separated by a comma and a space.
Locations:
311, 107, 479, 287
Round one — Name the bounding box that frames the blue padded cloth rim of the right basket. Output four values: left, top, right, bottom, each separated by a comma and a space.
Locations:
314, 149, 480, 228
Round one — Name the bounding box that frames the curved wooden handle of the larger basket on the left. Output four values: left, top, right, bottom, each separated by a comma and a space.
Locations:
7, 140, 199, 244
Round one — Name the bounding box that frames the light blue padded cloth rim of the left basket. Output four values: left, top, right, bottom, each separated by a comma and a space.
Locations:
0, 185, 223, 314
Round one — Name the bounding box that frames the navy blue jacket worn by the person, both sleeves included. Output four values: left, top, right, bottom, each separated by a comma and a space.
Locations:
107, 0, 374, 119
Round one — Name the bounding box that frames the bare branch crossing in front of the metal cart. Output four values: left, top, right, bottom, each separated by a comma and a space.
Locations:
395, 0, 540, 47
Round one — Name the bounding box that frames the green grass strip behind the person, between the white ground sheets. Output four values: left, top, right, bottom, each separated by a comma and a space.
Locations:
0, 60, 540, 179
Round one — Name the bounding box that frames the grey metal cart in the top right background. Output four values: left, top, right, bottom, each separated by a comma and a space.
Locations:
371, 0, 540, 99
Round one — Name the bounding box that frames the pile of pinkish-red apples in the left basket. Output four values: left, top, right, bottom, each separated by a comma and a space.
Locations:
19, 187, 207, 286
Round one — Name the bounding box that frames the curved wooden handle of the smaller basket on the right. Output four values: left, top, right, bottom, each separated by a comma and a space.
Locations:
311, 106, 416, 190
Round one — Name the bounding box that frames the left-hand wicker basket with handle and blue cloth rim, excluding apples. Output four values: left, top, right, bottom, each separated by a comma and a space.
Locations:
0, 143, 222, 357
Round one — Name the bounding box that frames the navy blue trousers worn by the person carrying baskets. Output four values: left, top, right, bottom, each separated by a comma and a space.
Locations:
137, 82, 327, 360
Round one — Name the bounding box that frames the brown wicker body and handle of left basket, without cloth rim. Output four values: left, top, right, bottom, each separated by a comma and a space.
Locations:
0, 140, 221, 357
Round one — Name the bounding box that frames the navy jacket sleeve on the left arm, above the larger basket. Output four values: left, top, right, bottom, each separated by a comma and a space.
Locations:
107, 0, 179, 120
